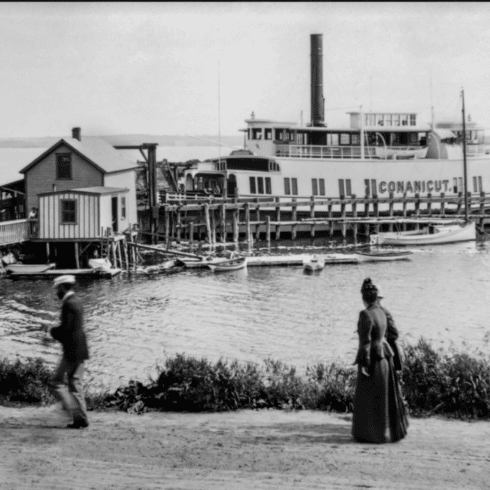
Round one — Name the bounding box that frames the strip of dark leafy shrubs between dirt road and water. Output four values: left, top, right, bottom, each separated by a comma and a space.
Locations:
0, 339, 490, 419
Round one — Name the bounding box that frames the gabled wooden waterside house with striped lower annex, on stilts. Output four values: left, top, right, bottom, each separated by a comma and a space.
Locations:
21, 128, 138, 268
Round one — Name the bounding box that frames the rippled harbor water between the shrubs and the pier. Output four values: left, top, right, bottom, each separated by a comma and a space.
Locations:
0, 239, 490, 389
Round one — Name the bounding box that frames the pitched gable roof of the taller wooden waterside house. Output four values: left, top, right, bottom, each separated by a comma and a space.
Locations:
20, 136, 138, 173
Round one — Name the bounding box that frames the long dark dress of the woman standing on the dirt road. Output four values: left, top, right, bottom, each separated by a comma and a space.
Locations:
352, 303, 408, 443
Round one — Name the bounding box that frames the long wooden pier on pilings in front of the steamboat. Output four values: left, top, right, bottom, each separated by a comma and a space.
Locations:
147, 192, 490, 247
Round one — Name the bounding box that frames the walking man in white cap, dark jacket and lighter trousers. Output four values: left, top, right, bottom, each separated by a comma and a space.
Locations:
48, 275, 89, 429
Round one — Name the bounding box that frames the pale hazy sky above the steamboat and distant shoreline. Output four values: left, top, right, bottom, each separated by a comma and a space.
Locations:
0, 2, 490, 138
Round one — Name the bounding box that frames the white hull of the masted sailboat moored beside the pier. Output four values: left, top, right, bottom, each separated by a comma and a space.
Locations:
371, 223, 476, 245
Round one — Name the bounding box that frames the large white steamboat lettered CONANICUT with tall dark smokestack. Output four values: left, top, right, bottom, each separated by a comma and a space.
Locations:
185, 34, 490, 205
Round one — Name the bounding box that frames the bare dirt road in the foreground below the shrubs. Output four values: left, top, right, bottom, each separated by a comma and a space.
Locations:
0, 407, 490, 490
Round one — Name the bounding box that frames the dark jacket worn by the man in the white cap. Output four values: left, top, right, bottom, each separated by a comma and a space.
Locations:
51, 294, 89, 362
